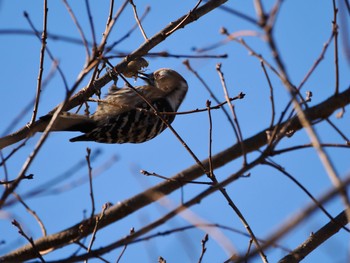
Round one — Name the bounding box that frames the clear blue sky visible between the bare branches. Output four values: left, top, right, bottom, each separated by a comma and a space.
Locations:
0, 0, 350, 262
